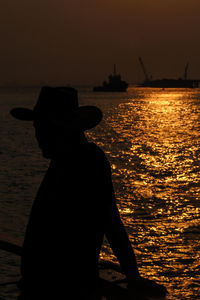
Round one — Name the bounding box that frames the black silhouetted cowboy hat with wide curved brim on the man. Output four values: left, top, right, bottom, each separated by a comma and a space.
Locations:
10, 86, 102, 130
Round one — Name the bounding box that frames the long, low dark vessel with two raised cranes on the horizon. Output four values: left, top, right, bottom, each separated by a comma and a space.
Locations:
139, 57, 200, 88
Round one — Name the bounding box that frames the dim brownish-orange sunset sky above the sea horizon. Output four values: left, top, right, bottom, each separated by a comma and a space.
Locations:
0, 0, 200, 86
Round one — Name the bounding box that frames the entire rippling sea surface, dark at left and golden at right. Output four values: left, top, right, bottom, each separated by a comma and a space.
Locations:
0, 88, 200, 300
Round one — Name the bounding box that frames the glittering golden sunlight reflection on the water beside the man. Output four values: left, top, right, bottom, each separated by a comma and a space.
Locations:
95, 89, 200, 299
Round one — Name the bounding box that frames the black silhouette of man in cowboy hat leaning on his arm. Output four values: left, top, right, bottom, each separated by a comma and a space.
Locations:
11, 87, 166, 300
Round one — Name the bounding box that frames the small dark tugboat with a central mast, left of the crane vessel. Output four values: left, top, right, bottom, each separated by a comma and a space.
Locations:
93, 65, 128, 92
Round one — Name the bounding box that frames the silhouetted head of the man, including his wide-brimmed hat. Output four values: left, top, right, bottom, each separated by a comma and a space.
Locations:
11, 87, 102, 158
